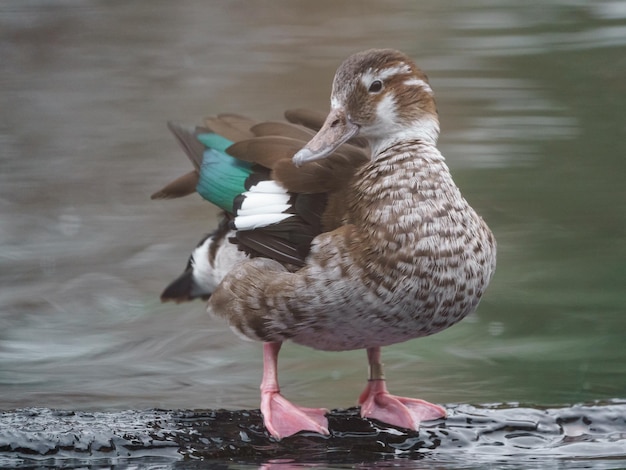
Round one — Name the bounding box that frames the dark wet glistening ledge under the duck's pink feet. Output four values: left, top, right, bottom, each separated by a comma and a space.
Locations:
0, 401, 626, 464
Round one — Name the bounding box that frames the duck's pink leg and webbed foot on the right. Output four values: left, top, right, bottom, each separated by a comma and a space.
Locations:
359, 348, 446, 431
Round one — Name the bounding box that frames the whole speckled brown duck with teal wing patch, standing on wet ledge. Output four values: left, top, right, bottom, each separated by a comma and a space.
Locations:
153, 49, 497, 439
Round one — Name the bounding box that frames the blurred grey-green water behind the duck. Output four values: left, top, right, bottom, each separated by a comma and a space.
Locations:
0, 0, 626, 468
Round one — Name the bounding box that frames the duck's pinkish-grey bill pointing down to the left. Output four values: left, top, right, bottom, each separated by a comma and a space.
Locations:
293, 108, 359, 166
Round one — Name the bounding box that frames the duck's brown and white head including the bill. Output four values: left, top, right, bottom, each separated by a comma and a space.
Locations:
293, 49, 439, 166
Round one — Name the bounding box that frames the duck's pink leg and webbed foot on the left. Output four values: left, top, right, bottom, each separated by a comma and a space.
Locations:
261, 343, 330, 439
